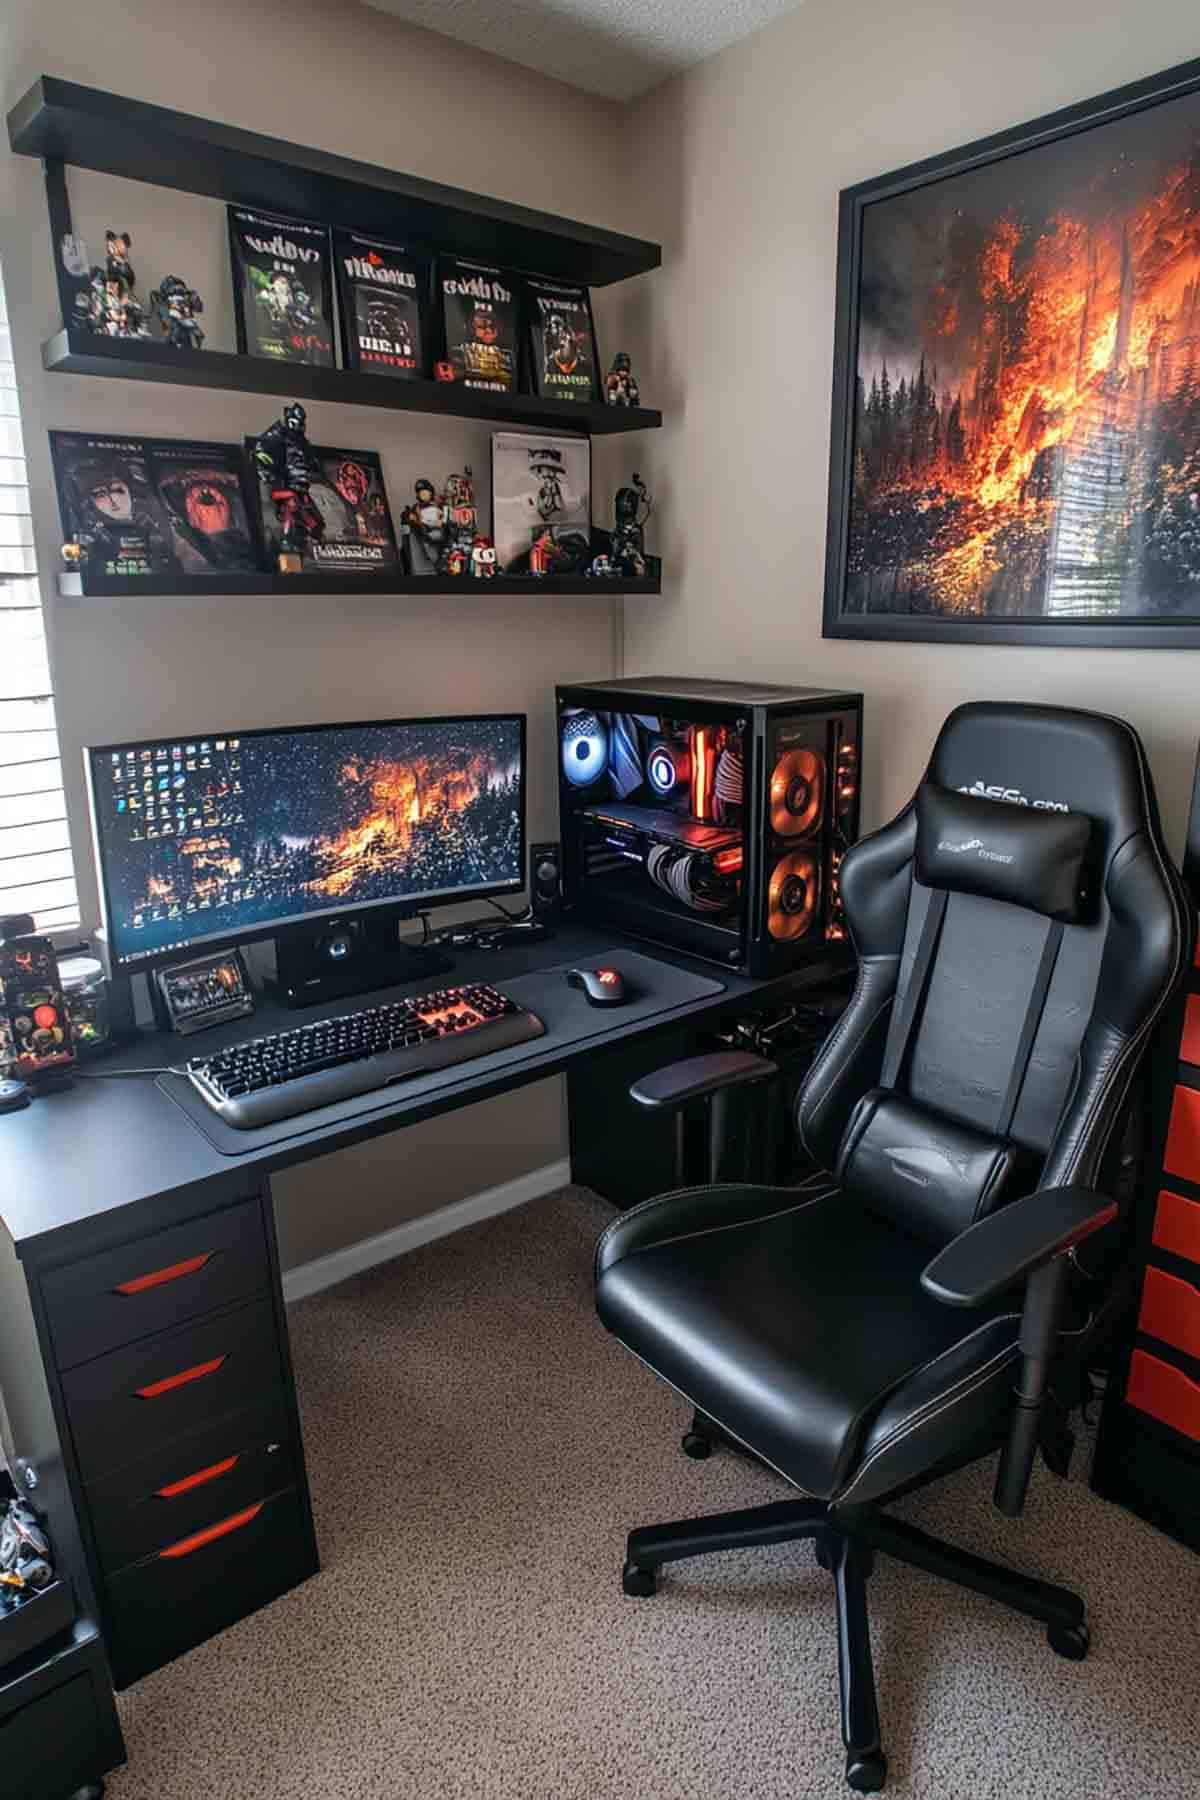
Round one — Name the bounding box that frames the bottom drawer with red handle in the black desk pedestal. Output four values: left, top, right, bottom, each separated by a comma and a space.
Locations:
106, 1489, 317, 1687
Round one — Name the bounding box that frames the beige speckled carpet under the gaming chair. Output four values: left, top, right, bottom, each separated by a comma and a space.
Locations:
110, 1190, 1200, 1800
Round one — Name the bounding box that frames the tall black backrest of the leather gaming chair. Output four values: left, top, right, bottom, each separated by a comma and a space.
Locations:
797, 704, 1195, 1235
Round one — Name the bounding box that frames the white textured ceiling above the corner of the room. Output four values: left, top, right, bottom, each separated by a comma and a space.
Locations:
363, 0, 802, 101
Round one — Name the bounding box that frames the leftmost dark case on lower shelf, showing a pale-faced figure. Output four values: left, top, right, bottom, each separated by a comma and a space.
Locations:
50, 432, 176, 578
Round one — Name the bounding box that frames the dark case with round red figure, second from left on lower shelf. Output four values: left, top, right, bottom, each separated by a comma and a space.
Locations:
146, 437, 259, 574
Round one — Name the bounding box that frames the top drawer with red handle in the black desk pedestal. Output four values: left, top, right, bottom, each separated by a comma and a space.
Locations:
41, 1195, 268, 1368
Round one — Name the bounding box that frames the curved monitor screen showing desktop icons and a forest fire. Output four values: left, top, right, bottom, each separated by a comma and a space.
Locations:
85, 715, 525, 968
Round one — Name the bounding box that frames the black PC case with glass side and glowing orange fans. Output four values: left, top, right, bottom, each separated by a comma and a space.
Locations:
558, 677, 862, 976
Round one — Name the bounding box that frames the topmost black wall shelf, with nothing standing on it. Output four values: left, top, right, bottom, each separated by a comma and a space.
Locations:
9, 76, 662, 288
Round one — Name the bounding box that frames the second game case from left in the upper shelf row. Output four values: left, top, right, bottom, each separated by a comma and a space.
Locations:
333, 230, 428, 382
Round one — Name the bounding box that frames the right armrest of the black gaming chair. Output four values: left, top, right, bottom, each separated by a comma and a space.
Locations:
921, 1188, 1117, 1307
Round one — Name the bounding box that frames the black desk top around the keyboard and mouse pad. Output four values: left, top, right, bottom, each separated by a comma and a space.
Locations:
0, 925, 844, 1255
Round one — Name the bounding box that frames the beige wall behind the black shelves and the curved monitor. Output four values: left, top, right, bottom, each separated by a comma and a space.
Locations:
0, 0, 622, 1265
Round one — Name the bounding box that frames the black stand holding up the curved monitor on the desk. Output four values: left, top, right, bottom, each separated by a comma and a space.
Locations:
270, 913, 453, 1006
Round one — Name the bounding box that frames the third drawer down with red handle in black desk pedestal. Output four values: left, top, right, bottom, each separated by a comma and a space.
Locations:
88, 1391, 295, 1570
